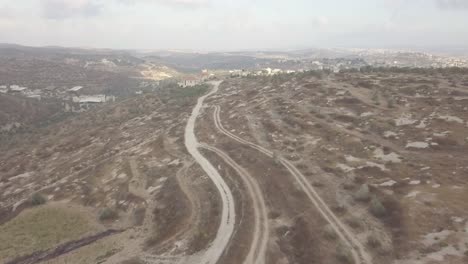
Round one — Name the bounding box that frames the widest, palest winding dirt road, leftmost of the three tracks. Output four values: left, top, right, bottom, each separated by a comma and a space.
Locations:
185, 82, 236, 264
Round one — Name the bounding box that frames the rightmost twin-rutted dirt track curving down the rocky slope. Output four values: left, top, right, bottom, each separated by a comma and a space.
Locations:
213, 106, 372, 264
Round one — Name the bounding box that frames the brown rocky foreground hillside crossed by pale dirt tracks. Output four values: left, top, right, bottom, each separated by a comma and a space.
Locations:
0, 68, 468, 264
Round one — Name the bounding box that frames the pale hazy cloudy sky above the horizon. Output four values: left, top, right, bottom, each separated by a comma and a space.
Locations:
0, 0, 468, 51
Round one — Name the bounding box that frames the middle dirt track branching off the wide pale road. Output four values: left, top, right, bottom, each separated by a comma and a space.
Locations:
201, 144, 269, 264
